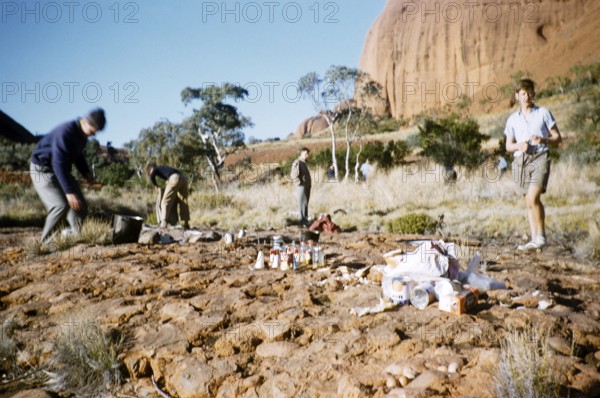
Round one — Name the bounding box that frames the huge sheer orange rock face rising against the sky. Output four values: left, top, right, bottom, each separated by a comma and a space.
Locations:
359, 0, 600, 117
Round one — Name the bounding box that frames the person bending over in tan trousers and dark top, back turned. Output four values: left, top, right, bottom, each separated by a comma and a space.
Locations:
146, 162, 190, 229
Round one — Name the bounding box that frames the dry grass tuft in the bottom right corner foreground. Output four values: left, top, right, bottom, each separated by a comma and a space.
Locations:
494, 329, 561, 398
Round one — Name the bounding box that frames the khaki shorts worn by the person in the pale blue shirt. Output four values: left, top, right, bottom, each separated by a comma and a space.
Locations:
512, 151, 550, 195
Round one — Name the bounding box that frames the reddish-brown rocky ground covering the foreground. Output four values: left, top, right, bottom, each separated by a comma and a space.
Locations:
0, 227, 600, 398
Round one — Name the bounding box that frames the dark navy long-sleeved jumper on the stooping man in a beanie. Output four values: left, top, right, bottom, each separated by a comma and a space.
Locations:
31, 119, 91, 194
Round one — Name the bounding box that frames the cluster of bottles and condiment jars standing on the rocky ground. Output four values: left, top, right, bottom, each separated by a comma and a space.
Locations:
269, 239, 325, 271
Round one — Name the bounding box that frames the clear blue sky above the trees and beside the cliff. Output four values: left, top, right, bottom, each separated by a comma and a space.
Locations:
0, 0, 385, 146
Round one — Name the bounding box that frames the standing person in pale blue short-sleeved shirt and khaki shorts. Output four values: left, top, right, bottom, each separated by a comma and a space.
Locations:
504, 79, 562, 251
